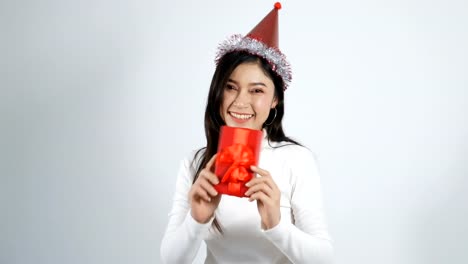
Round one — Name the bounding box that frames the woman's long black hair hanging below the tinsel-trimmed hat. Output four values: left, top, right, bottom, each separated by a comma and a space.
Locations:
192, 51, 300, 233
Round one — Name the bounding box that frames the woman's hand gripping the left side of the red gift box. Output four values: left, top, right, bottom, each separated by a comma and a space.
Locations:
189, 155, 221, 224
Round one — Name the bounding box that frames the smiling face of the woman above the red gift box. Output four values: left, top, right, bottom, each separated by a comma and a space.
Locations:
221, 62, 278, 130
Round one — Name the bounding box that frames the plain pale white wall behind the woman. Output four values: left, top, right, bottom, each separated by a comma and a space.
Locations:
0, 0, 468, 264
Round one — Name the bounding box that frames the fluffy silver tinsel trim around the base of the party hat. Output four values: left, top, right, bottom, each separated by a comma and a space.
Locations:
215, 34, 292, 90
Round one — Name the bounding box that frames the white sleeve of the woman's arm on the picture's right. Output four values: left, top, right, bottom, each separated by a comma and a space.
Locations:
264, 147, 333, 264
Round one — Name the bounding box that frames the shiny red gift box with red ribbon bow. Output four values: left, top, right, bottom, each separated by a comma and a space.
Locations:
214, 126, 263, 197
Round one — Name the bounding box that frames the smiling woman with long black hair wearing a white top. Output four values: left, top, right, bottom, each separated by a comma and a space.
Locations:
161, 3, 332, 263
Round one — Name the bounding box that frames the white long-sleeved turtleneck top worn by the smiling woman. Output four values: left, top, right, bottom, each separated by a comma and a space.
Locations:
161, 138, 332, 264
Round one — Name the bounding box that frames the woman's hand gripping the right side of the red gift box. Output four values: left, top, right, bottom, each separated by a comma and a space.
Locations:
245, 166, 281, 230
